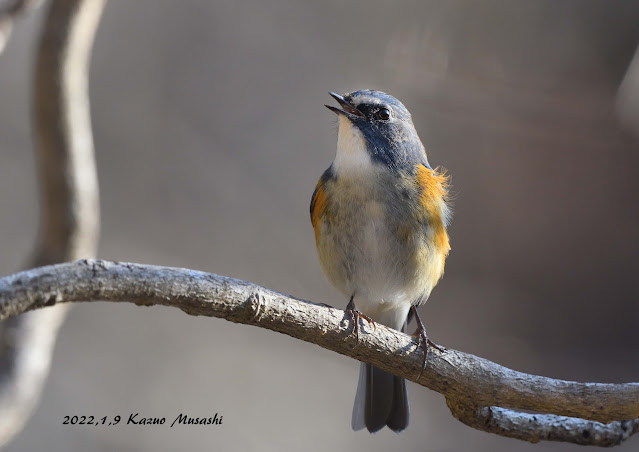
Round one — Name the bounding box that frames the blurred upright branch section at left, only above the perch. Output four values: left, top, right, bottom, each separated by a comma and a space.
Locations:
33, 0, 105, 265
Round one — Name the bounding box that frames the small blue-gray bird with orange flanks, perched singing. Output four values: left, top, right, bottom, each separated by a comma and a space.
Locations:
311, 90, 451, 433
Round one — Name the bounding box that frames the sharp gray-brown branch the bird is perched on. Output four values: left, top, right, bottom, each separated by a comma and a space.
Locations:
0, 260, 639, 446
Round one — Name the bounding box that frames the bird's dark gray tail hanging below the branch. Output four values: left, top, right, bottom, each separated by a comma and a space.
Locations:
351, 363, 409, 433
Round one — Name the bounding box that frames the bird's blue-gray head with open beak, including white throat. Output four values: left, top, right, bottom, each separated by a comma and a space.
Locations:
326, 90, 430, 169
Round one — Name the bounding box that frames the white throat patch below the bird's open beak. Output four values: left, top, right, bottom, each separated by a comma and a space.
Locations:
333, 115, 373, 175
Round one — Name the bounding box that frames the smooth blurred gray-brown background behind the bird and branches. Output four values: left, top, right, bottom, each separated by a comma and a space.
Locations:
0, 0, 639, 452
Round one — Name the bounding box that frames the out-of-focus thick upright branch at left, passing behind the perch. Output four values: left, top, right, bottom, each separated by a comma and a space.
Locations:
0, 0, 105, 446
